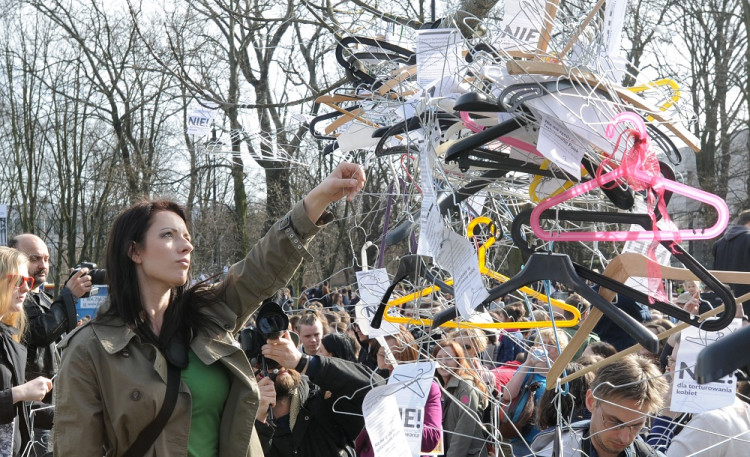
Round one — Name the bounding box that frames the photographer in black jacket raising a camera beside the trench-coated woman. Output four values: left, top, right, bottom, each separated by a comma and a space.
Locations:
255, 332, 382, 457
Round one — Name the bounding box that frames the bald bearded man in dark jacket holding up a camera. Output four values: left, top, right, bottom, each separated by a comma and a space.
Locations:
9, 233, 91, 382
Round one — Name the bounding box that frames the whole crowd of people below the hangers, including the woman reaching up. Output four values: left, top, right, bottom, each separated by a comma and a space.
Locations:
0, 163, 750, 457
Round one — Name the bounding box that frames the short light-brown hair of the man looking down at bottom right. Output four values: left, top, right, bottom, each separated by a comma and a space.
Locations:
591, 354, 668, 414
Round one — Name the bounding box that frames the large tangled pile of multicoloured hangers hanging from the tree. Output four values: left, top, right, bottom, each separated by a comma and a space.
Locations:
309, 2, 749, 382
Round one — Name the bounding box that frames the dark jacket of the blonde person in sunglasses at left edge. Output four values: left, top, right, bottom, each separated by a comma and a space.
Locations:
0, 323, 52, 456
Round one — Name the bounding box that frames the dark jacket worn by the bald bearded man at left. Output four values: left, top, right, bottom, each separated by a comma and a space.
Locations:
23, 287, 77, 382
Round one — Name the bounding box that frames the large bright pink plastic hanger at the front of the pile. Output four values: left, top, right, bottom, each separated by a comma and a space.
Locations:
530, 112, 729, 242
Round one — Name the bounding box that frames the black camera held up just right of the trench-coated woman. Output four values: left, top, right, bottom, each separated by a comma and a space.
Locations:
240, 299, 289, 371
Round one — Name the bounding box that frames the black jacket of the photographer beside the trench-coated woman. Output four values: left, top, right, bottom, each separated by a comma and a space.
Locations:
255, 356, 382, 457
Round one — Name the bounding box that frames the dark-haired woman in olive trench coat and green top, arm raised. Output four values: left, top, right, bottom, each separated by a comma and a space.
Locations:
53, 163, 365, 457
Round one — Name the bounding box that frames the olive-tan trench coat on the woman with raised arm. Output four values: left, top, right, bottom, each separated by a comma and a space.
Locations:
53, 202, 318, 457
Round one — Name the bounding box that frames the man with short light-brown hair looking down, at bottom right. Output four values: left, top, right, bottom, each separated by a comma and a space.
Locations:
531, 355, 668, 457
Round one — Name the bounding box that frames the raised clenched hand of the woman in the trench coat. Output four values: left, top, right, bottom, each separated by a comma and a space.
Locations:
304, 162, 365, 222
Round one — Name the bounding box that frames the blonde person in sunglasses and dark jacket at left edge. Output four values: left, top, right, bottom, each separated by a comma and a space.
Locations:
0, 247, 52, 456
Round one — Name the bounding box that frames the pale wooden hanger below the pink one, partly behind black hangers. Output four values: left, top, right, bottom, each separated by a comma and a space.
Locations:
547, 252, 750, 388
